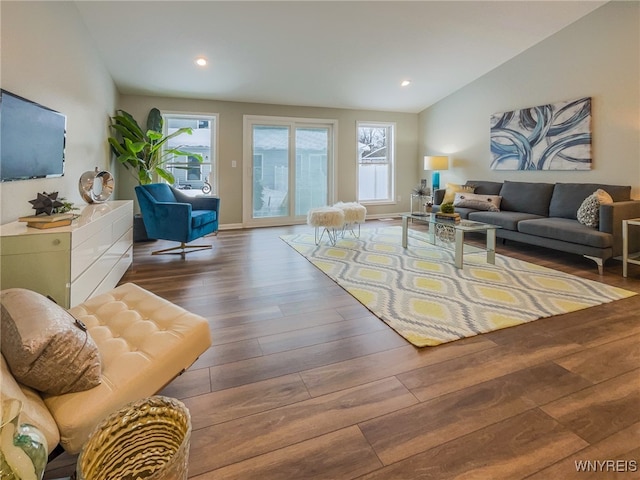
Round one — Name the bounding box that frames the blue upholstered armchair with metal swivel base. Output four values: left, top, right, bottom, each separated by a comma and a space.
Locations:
136, 183, 220, 256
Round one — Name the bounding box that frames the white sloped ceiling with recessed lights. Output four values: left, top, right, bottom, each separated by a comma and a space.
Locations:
76, 0, 607, 113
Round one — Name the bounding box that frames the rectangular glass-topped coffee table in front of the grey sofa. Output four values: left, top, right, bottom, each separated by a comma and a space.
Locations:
402, 213, 502, 268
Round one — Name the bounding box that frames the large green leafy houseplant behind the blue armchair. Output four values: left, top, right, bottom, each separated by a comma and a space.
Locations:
108, 108, 202, 185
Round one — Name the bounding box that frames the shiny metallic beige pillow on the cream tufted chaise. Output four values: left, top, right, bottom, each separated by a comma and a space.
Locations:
0, 288, 102, 395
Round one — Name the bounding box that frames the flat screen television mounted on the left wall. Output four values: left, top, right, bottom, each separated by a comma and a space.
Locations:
0, 90, 67, 182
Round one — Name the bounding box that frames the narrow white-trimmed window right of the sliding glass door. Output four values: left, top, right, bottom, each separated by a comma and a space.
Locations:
356, 122, 395, 203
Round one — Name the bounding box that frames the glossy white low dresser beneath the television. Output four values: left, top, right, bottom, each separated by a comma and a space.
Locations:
0, 200, 133, 308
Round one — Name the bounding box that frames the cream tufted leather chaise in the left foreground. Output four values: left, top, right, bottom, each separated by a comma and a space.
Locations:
2, 283, 211, 454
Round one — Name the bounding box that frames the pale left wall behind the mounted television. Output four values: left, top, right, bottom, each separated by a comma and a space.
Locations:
0, 2, 118, 223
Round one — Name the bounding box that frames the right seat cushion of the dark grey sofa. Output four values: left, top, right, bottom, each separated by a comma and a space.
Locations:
518, 217, 613, 248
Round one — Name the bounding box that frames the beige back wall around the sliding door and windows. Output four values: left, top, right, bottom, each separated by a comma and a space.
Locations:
118, 95, 419, 225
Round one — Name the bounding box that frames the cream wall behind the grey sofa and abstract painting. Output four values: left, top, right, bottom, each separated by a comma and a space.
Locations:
419, 1, 640, 198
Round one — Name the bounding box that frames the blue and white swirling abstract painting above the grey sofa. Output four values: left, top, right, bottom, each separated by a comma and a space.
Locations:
491, 97, 591, 170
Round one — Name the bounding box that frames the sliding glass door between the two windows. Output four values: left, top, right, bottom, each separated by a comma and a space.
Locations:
243, 117, 334, 226
